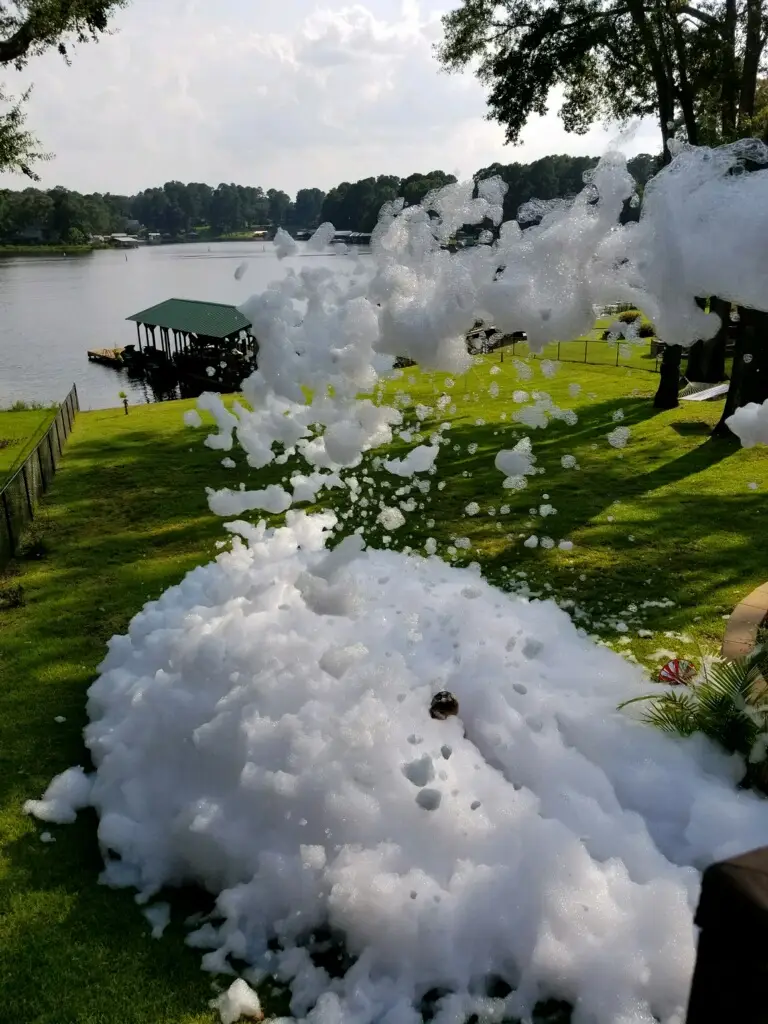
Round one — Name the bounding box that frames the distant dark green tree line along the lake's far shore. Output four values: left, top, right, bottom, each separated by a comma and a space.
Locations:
0, 154, 659, 246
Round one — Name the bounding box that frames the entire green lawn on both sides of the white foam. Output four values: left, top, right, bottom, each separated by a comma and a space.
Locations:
0, 351, 768, 1024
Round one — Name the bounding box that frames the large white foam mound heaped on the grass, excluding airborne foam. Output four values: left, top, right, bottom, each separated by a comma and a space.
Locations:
33, 512, 768, 1024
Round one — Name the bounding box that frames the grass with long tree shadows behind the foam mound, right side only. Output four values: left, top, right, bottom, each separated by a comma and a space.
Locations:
370, 354, 768, 665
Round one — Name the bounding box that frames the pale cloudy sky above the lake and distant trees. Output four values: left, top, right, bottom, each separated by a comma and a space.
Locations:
0, 0, 658, 196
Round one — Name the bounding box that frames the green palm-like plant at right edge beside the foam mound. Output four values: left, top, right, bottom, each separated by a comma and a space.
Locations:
618, 646, 768, 793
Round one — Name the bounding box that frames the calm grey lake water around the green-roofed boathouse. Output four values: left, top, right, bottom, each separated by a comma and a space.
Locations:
0, 242, 365, 409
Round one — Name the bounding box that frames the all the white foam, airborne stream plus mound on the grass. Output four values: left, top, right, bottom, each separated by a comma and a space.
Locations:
27, 143, 768, 1024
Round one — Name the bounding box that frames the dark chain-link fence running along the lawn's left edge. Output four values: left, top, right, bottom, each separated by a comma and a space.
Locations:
0, 384, 80, 565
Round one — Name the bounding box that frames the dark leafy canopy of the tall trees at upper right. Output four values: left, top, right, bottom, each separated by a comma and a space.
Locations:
437, 0, 768, 145
